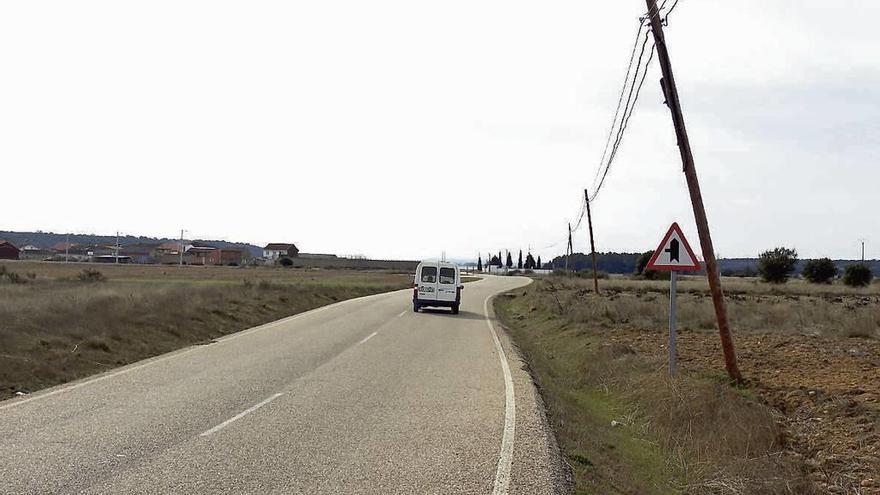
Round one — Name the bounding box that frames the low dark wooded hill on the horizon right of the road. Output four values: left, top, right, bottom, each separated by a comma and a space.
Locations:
545, 253, 880, 276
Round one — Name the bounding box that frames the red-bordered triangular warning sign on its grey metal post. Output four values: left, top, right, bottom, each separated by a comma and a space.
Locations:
645, 223, 701, 376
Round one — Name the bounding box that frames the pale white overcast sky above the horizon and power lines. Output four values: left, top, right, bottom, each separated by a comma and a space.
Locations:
0, 0, 880, 259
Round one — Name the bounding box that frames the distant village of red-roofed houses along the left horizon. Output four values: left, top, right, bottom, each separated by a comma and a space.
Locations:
0, 240, 316, 266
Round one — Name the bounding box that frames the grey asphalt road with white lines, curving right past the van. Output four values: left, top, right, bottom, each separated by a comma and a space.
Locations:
0, 277, 564, 494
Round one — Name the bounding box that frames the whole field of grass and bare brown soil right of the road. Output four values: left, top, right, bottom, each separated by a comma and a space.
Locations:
495, 277, 880, 494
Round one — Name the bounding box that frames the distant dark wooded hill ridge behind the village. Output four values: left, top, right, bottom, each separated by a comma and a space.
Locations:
0, 230, 263, 257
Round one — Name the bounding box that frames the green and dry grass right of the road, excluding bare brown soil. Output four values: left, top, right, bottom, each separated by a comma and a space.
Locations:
496, 277, 820, 495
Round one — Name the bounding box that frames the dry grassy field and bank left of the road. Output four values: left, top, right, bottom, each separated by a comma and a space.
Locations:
0, 262, 412, 400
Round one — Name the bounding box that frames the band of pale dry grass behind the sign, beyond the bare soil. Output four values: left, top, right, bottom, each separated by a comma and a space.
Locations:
544, 277, 880, 338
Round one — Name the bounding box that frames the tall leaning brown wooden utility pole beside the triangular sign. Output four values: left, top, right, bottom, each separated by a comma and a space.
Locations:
645, 0, 742, 382
